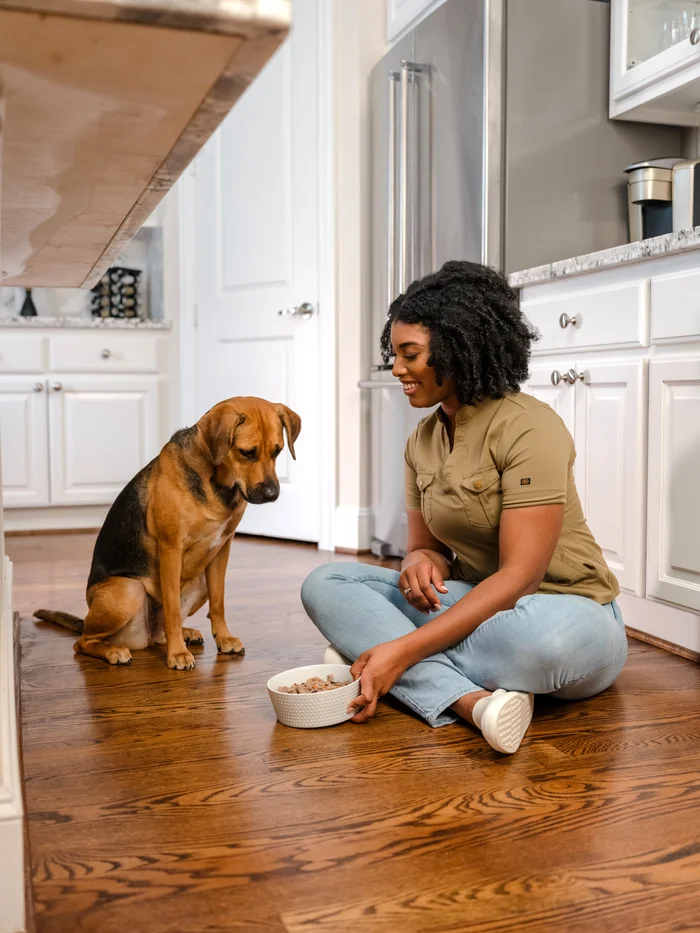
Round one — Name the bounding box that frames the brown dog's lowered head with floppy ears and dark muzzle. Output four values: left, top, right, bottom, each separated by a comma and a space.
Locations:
197, 398, 301, 504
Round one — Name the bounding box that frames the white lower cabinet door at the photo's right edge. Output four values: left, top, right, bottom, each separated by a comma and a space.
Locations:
647, 358, 700, 612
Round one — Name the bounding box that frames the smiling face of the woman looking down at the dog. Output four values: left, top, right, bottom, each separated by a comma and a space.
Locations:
391, 321, 455, 408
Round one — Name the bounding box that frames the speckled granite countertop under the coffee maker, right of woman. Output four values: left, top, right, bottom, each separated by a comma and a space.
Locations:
508, 227, 700, 288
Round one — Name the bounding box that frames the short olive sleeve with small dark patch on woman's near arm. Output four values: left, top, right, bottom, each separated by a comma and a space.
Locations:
499, 408, 575, 509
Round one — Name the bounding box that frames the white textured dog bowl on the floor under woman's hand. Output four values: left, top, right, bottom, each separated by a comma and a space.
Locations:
267, 664, 360, 729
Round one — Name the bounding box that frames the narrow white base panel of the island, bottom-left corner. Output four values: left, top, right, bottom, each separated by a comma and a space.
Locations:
0, 557, 25, 933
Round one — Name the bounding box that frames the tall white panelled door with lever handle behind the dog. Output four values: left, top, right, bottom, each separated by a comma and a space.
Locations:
194, 0, 320, 541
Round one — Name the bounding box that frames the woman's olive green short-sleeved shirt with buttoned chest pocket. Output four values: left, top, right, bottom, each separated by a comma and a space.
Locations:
406, 392, 620, 603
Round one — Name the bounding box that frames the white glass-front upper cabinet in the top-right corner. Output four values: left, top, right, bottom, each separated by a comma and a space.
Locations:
610, 0, 700, 126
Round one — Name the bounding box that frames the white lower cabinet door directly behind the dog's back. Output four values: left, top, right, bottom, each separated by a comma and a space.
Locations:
49, 375, 159, 505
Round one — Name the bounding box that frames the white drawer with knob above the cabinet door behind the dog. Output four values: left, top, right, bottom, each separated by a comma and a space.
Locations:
50, 333, 164, 373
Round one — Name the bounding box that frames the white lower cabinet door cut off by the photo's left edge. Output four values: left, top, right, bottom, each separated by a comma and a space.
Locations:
0, 375, 49, 507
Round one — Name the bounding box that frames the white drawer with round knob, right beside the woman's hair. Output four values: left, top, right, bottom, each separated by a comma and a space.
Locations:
521, 279, 649, 353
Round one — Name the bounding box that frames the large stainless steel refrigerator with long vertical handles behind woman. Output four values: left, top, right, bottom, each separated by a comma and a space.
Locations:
360, 0, 682, 556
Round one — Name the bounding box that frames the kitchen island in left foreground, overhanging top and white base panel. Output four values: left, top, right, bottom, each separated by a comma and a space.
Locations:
0, 0, 291, 933
